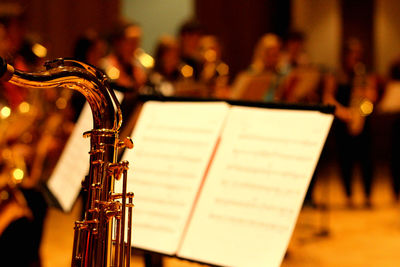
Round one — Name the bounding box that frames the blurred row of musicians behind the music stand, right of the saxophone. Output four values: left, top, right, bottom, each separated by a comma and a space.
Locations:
68, 20, 400, 211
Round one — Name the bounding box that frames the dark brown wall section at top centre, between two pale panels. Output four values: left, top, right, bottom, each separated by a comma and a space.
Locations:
196, 0, 290, 79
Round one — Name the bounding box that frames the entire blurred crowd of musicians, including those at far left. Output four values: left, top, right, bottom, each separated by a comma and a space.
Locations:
0, 12, 400, 266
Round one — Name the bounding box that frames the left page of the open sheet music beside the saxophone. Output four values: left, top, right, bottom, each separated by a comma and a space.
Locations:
123, 102, 229, 255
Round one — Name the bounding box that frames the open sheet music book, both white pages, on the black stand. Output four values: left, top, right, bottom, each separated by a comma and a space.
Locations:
119, 101, 333, 266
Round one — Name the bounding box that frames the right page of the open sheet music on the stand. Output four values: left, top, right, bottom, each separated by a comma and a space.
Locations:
178, 107, 333, 267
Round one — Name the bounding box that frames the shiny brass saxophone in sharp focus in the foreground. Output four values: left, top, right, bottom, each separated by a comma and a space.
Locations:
0, 58, 133, 267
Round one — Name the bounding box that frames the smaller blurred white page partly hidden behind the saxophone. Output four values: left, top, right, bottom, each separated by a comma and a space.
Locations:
47, 91, 123, 214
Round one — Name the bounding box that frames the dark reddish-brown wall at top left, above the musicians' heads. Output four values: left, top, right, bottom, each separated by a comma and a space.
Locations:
0, 0, 119, 58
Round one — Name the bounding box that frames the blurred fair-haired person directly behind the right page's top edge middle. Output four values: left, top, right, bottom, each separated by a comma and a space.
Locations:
231, 33, 286, 101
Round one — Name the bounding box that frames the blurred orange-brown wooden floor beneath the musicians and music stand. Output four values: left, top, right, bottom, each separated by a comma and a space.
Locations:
41, 163, 400, 267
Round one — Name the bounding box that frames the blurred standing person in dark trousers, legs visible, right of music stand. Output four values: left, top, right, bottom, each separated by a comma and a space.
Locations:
323, 39, 377, 207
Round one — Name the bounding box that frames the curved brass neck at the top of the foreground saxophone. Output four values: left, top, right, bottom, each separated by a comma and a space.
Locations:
0, 58, 122, 131
